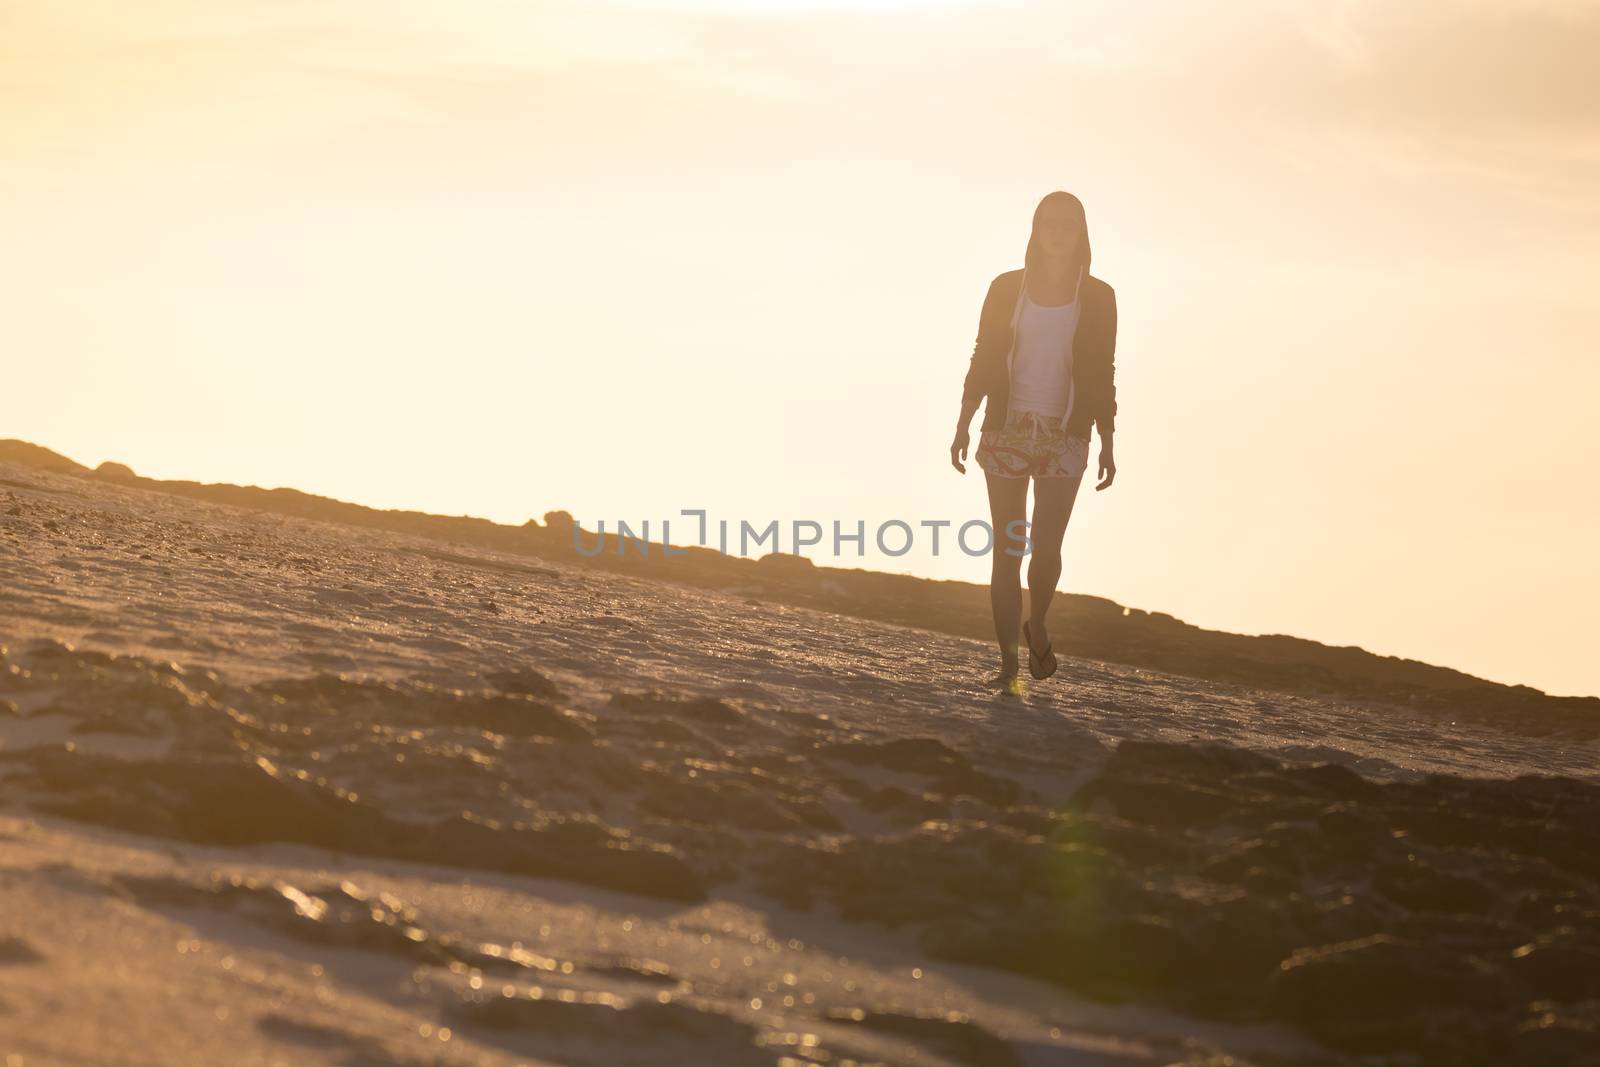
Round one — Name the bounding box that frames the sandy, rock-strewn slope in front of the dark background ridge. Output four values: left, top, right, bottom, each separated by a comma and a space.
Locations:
0, 462, 1600, 1067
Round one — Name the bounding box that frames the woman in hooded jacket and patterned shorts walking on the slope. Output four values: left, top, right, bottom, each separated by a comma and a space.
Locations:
950, 190, 1117, 693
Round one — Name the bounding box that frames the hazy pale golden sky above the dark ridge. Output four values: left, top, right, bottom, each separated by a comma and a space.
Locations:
0, 0, 1600, 694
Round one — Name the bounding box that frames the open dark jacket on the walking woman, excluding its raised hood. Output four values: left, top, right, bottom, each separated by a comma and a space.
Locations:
962, 267, 1117, 438
